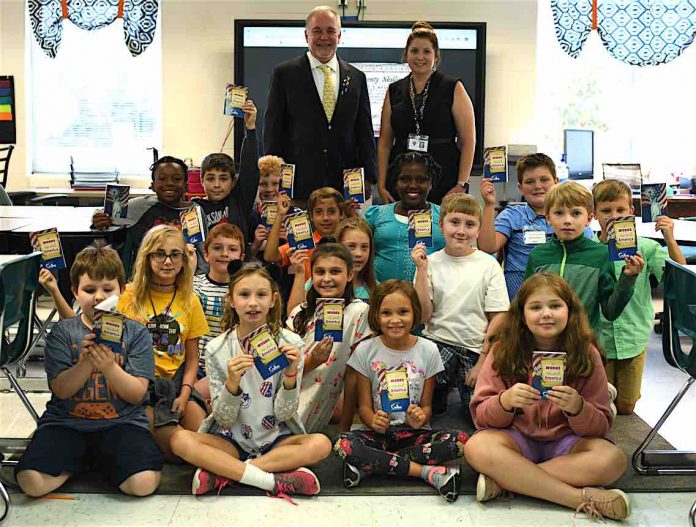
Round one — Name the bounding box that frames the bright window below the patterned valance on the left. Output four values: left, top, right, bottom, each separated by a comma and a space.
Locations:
27, 16, 162, 178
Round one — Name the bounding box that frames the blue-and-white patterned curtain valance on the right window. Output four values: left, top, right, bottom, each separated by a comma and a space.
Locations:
551, 0, 696, 66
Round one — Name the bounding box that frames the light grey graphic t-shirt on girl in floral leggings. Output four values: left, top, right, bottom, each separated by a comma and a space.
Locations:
348, 337, 445, 430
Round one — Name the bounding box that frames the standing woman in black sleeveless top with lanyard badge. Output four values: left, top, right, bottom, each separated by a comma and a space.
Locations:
377, 22, 476, 204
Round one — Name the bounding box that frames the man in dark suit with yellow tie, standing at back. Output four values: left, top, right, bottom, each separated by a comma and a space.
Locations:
263, 6, 377, 206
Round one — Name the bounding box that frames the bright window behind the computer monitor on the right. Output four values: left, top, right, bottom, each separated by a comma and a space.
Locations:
536, 1, 696, 182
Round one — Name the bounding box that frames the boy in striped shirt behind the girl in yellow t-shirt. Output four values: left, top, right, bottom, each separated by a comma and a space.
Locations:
193, 223, 245, 400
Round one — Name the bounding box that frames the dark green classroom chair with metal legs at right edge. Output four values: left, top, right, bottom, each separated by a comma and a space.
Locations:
632, 259, 696, 475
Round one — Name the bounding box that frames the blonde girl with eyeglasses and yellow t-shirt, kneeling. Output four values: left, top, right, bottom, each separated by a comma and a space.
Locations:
118, 225, 208, 456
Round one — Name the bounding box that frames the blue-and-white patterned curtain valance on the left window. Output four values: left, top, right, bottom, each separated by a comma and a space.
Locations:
29, 0, 159, 58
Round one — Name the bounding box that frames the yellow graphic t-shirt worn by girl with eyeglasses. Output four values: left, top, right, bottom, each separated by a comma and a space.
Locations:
118, 284, 208, 379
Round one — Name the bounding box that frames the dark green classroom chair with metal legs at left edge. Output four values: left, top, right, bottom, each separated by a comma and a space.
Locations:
0, 252, 41, 521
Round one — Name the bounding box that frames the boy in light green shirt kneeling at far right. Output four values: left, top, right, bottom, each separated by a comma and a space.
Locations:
592, 179, 686, 414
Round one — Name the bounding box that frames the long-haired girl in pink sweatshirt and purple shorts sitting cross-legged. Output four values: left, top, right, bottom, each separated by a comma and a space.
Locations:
464, 273, 630, 520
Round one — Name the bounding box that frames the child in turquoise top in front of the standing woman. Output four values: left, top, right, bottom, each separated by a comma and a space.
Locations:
365, 152, 445, 282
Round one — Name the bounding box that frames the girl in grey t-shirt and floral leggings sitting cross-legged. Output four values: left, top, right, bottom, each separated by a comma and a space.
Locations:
334, 280, 468, 502
